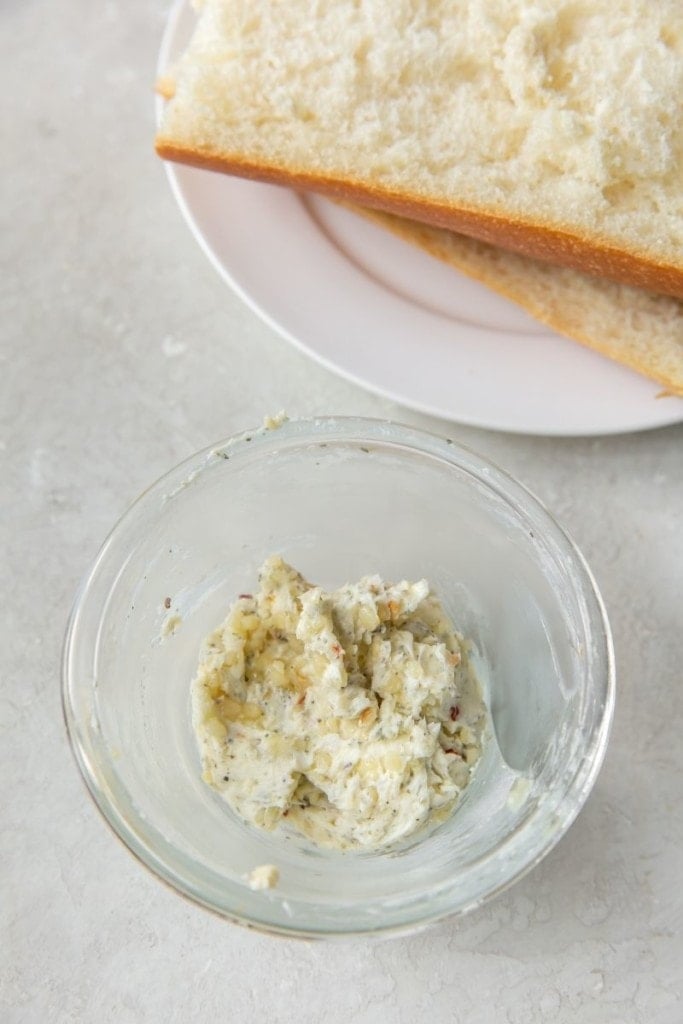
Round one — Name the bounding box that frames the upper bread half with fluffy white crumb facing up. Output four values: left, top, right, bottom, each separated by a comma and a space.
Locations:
157, 0, 683, 297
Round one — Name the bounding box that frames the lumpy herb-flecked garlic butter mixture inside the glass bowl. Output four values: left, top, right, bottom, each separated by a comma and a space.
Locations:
193, 556, 486, 849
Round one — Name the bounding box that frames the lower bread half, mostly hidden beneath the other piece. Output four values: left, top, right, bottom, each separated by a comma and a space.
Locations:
344, 204, 683, 397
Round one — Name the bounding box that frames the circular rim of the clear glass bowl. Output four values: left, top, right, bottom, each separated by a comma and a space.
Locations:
61, 416, 615, 939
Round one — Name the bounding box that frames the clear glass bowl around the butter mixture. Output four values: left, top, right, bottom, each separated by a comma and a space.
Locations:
63, 418, 614, 937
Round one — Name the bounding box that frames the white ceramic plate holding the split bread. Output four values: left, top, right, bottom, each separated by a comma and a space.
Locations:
160, 0, 683, 436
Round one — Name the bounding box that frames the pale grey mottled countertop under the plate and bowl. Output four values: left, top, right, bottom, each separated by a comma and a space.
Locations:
0, 0, 683, 1024
